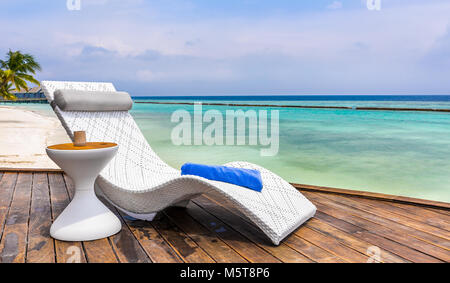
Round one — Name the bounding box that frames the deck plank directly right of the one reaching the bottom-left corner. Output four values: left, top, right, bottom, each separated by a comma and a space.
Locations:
26, 173, 55, 263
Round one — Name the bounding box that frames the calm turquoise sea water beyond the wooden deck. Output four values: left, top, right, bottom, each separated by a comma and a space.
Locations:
11, 96, 450, 202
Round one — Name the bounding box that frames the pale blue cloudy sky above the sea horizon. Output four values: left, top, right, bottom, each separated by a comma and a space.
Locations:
0, 0, 450, 96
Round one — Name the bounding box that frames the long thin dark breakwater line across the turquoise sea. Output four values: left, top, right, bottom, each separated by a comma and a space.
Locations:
135, 101, 450, 113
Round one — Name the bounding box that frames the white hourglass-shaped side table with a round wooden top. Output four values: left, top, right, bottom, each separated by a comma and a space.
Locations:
47, 143, 122, 241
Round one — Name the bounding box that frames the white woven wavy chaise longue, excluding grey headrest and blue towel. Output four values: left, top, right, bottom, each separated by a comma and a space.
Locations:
42, 81, 316, 245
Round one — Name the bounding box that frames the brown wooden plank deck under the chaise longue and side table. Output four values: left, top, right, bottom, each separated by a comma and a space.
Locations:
0, 172, 450, 263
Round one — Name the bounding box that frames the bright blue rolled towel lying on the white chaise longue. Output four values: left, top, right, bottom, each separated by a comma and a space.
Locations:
181, 163, 263, 192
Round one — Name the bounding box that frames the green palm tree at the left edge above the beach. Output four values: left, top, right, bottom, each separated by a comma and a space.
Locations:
0, 50, 41, 99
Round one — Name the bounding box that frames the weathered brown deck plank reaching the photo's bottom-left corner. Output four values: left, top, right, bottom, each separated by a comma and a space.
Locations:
0, 174, 32, 263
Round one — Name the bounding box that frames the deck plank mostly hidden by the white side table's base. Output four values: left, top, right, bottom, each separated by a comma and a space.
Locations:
64, 174, 119, 263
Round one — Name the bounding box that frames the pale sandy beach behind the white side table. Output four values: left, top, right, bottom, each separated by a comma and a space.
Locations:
0, 106, 70, 169
